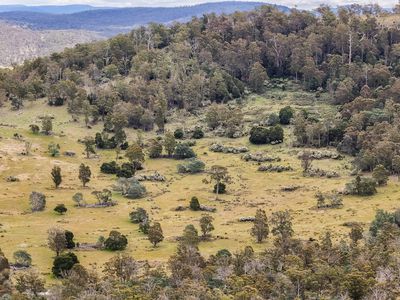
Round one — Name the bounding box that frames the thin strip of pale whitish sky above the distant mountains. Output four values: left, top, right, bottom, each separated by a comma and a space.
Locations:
1, 0, 398, 9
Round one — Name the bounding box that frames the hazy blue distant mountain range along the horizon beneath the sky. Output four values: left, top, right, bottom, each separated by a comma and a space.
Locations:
0, 1, 289, 36
